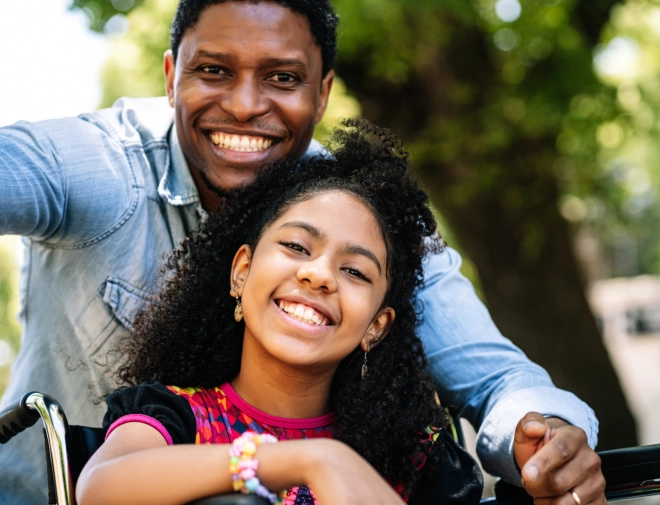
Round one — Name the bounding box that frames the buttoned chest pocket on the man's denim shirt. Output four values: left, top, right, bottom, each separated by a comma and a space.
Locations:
75, 276, 151, 358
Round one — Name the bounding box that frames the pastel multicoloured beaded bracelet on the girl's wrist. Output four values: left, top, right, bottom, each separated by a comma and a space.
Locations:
229, 431, 285, 505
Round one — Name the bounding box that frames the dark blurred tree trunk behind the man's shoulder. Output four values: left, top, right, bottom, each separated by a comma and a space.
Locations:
337, 4, 637, 450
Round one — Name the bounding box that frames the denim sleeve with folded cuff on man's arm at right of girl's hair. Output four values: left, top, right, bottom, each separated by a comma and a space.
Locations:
419, 248, 598, 483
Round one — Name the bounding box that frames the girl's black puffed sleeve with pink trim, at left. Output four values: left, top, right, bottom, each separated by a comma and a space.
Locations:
103, 382, 197, 444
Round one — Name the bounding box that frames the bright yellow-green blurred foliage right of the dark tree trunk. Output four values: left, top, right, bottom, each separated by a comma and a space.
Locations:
558, 0, 660, 275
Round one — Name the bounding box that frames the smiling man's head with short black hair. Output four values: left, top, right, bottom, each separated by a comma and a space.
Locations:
165, 1, 333, 203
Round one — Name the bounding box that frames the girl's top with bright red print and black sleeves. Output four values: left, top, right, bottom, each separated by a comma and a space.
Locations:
103, 382, 483, 505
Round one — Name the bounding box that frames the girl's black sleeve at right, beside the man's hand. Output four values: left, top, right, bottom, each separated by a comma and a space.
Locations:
408, 430, 484, 505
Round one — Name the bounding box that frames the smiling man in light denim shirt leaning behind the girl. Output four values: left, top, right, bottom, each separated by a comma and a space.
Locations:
0, 0, 604, 505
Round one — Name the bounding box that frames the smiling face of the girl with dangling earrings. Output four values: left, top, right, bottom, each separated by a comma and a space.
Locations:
232, 191, 394, 372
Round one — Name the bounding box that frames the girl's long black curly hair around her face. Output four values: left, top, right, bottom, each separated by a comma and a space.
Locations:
120, 120, 446, 493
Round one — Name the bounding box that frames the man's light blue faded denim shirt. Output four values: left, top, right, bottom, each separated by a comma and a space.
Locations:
0, 98, 597, 504
